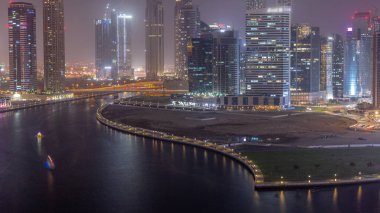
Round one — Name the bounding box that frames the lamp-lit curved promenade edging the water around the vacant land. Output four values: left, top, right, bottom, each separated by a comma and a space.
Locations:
97, 105, 380, 190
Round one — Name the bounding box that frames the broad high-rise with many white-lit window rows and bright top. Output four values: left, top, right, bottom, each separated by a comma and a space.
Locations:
245, 7, 291, 107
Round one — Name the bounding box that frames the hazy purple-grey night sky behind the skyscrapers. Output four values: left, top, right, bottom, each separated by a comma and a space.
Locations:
0, 0, 380, 67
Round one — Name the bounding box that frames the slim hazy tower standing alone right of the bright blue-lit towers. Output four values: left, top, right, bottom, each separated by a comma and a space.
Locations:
145, 0, 164, 80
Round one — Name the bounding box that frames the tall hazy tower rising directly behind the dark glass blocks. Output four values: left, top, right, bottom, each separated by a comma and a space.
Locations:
175, 0, 200, 79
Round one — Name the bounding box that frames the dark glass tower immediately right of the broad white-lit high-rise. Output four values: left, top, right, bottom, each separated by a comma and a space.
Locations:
290, 24, 321, 104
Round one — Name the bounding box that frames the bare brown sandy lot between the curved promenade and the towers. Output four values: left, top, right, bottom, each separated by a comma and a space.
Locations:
103, 105, 355, 144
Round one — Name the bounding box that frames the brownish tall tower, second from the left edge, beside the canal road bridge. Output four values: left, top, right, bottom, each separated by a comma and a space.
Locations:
43, 0, 65, 92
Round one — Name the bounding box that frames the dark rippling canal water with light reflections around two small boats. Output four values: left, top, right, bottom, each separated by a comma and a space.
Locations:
0, 96, 380, 213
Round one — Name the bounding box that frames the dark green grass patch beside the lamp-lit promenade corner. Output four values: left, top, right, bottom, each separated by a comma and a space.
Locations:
245, 148, 380, 182
